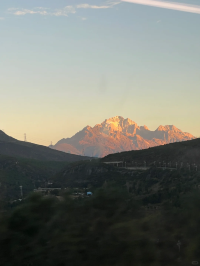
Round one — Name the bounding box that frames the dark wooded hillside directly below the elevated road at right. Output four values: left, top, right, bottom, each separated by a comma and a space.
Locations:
53, 160, 200, 208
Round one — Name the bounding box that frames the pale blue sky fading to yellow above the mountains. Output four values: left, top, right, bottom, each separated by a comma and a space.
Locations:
0, 0, 200, 145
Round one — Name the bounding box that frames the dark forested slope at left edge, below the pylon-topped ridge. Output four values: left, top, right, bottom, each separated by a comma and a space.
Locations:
0, 155, 68, 201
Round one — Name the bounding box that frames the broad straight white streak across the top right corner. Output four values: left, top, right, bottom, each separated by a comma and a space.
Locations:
122, 0, 200, 14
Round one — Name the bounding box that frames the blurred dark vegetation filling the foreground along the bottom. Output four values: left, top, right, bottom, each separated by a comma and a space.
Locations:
0, 187, 200, 266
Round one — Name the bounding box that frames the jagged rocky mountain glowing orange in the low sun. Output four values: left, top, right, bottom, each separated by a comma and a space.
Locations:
51, 116, 195, 157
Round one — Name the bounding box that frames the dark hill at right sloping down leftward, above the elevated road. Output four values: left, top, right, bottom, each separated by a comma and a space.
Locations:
101, 138, 200, 167
